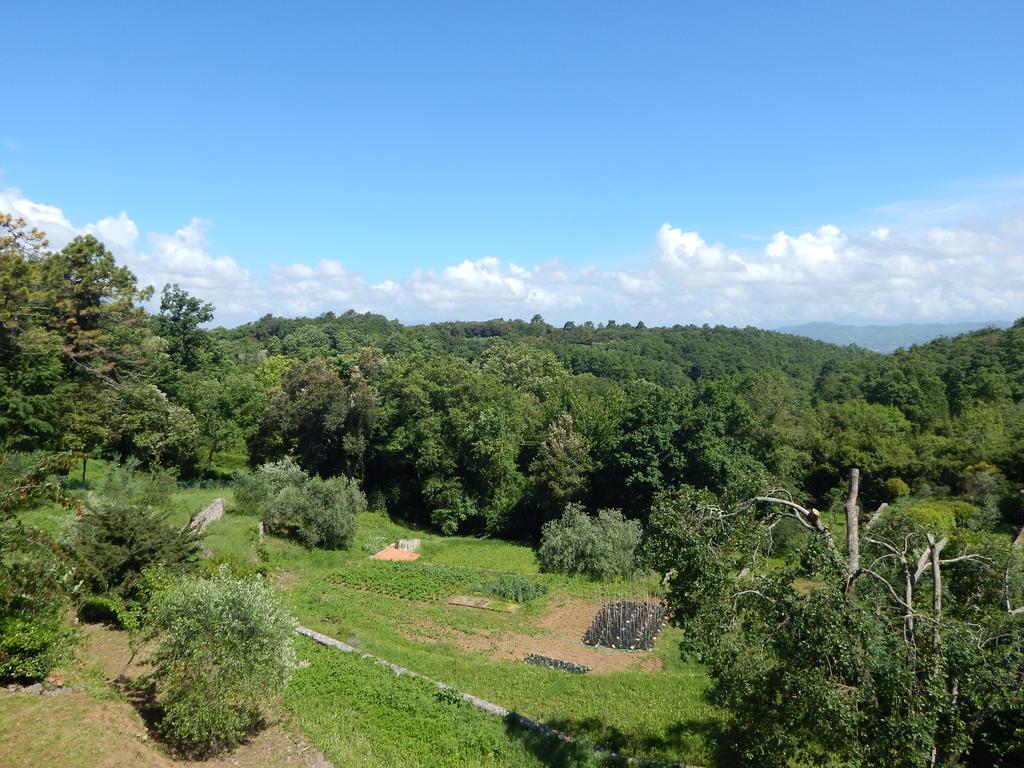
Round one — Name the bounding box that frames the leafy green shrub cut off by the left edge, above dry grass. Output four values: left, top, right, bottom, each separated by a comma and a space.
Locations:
0, 520, 74, 681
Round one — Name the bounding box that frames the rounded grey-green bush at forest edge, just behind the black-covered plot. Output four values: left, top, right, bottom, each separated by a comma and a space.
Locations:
538, 504, 641, 580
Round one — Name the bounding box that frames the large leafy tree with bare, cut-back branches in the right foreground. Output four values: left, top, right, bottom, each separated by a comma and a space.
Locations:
649, 476, 1024, 768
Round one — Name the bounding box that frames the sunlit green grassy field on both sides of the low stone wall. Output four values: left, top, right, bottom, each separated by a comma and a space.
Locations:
8, 463, 718, 766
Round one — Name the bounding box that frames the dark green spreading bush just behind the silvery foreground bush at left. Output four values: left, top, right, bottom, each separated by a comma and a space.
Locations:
71, 502, 200, 602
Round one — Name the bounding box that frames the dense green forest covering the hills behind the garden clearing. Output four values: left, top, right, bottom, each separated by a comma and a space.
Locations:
0, 219, 1024, 539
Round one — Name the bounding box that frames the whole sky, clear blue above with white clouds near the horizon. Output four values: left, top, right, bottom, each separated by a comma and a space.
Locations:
0, 0, 1024, 326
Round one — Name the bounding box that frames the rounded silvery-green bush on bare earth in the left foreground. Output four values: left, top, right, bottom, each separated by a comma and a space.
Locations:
142, 567, 295, 755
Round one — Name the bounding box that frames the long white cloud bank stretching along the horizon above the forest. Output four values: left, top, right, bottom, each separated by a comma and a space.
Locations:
0, 187, 1024, 328
